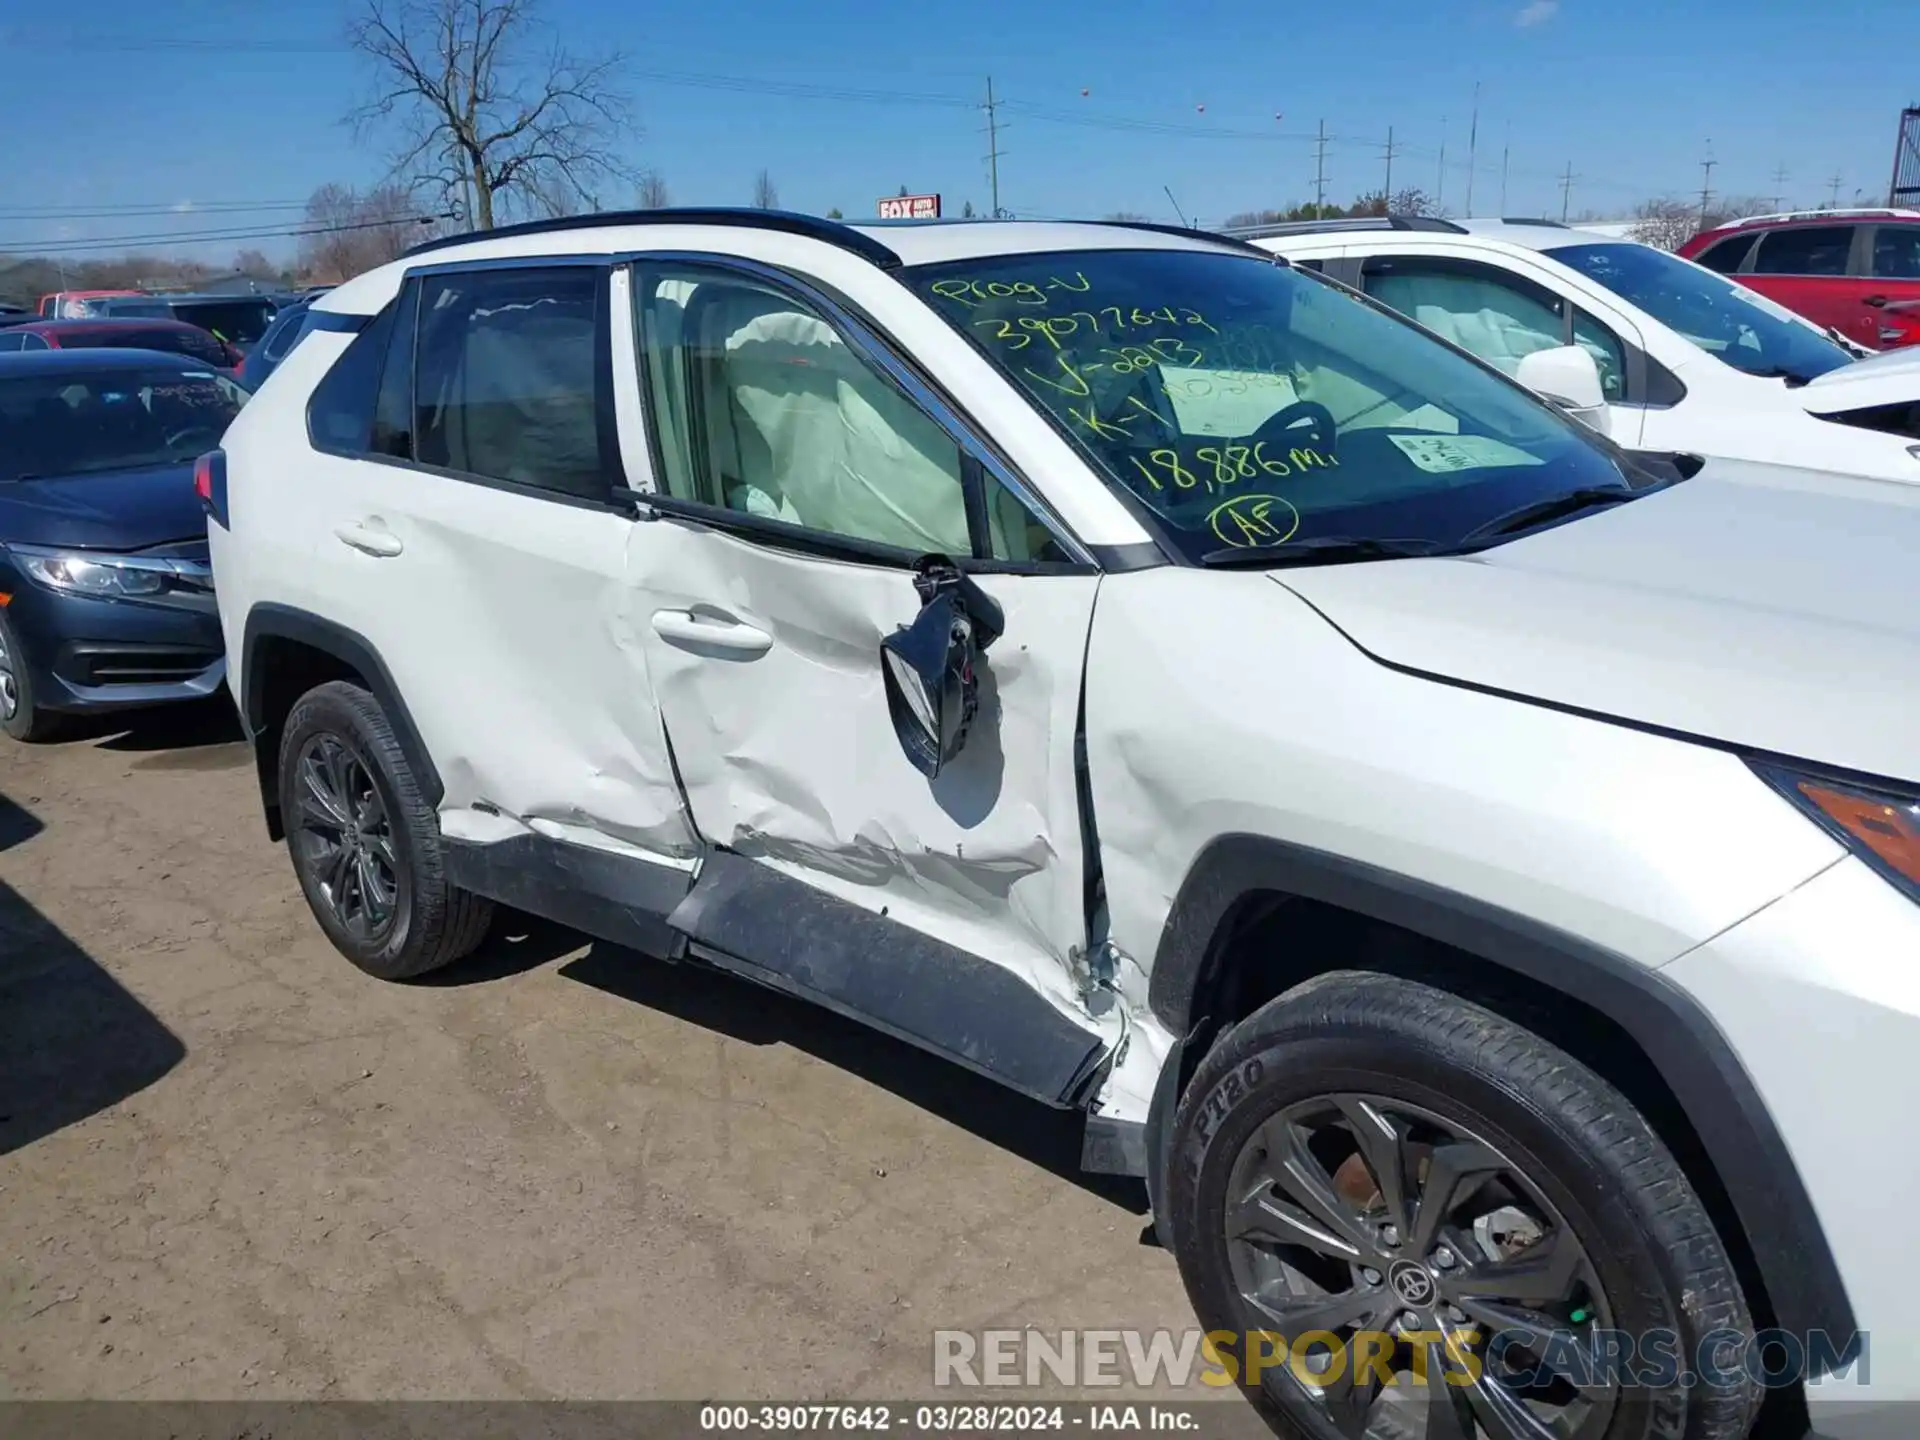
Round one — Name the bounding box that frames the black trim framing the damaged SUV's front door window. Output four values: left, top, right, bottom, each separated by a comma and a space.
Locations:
614, 250, 1100, 574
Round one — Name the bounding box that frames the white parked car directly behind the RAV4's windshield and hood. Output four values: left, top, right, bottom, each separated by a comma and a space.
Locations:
1235, 217, 1920, 484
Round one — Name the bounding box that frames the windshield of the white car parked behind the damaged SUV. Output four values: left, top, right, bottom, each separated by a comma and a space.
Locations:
1546, 244, 1853, 384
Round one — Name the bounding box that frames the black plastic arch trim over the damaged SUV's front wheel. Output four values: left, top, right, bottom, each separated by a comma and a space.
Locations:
1148, 835, 1857, 1336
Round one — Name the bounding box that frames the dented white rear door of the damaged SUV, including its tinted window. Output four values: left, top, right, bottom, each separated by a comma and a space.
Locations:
284, 257, 691, 868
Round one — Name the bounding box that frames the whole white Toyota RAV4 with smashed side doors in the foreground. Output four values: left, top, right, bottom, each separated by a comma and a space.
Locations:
200, 211, 1920, 1440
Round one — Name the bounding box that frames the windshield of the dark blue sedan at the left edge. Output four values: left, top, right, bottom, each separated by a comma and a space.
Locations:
0, 369, 246, 480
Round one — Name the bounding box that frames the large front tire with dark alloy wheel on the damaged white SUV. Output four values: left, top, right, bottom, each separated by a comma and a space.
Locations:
1167, 972, 1761, 1440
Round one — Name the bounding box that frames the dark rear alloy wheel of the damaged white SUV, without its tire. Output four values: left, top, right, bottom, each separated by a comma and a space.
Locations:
294, 732, 399, 943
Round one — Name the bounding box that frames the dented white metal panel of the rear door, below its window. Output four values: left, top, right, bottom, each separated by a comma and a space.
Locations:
323, 467, 695, 858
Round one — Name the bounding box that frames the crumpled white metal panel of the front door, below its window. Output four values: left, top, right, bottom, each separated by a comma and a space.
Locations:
630, 520, 1098, 1014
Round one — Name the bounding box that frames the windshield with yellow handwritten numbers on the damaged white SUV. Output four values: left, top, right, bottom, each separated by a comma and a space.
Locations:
906, 250, 1624, 559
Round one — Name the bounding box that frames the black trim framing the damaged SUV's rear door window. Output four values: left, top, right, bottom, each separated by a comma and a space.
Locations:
307, 255, 639, 516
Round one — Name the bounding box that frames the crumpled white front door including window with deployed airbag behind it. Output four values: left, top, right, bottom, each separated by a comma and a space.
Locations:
614, 263, 1098, 1010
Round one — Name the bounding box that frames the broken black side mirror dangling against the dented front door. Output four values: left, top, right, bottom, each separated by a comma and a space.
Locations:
879, 555, 1006, 780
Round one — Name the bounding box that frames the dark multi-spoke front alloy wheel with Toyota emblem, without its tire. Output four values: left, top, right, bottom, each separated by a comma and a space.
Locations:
1225, 1094, 1619, 1440
